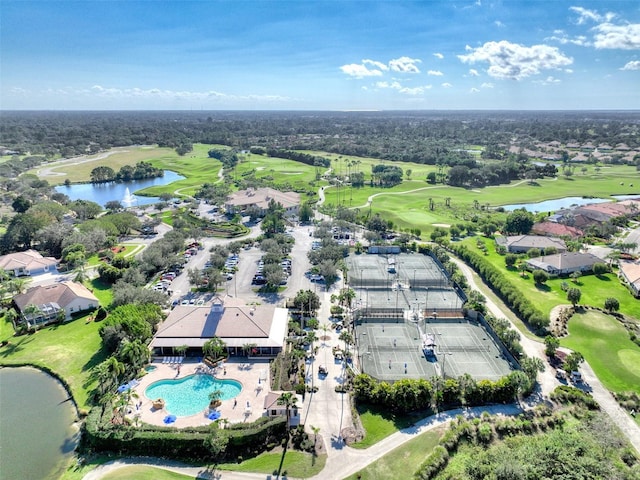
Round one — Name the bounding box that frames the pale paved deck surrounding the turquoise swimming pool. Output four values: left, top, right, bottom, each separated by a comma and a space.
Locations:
128, 358, 270, 428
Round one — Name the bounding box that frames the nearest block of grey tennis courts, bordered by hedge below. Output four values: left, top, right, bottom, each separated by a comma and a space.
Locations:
355, 318, 515, 381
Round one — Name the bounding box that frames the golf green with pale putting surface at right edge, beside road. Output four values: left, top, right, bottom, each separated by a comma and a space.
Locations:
560, 310, 640, 393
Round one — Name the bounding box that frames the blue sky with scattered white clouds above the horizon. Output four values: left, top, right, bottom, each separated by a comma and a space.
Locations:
0, 0, 640, 110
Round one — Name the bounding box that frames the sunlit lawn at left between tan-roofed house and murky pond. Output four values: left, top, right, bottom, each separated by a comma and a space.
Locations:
0, 317, 106, 409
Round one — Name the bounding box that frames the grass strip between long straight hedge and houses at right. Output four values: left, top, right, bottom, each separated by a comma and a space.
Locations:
463, 237, 640, 319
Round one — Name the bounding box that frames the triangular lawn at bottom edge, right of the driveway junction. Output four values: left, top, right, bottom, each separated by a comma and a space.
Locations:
347, 427, 445, 480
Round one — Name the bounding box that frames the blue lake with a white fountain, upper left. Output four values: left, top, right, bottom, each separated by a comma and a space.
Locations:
56, 170, 184, 207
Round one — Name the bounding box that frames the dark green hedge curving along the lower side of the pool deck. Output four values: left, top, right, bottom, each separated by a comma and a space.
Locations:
81, 408, 286, 461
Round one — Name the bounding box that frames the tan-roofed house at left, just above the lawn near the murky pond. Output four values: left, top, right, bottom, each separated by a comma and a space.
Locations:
13, 282, 100, 327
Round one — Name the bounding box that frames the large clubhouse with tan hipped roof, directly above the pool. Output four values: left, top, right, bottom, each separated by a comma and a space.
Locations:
150, 297, 288, 357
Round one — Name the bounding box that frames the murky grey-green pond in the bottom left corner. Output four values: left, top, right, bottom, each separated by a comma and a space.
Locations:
0, 368, 80, 480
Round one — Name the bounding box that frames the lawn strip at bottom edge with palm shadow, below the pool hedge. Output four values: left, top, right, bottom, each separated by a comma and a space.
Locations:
217, 450, 327, 478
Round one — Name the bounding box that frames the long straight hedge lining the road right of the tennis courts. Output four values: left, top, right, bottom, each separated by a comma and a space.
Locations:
450, 244, 549, 334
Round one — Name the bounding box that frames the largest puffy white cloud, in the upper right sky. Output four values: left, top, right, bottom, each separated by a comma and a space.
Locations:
458, 40, 573, 80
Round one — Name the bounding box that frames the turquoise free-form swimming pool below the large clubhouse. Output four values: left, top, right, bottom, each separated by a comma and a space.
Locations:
144, 374, 242, 417
